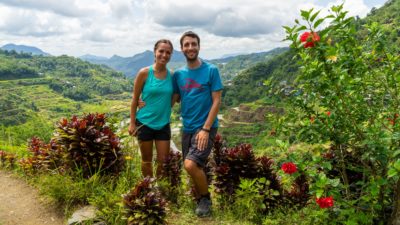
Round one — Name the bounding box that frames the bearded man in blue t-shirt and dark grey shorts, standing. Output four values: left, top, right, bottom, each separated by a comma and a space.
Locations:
173, 31, 223, 217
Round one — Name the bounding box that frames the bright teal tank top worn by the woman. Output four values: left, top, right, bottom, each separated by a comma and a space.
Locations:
136, 66, 173, 130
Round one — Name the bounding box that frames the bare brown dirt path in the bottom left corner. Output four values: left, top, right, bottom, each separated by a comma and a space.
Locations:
0, 170, 65, 225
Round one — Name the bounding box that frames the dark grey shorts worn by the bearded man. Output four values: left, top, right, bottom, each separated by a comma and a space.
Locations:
182, 127, 218, 168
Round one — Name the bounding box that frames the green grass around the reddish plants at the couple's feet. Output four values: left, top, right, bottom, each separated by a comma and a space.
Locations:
0, 134, 329, 225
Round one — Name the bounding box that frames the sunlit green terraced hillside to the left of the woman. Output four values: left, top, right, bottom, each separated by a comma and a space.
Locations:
0, 50, 132, 127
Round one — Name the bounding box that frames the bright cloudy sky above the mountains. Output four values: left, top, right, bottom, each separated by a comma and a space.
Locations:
0, 0, 385, 59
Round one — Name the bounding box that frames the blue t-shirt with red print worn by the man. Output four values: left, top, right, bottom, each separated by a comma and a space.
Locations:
173, 61, 223, 133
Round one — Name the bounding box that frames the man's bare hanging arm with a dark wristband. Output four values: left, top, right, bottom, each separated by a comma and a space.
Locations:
196, 90, 222, 150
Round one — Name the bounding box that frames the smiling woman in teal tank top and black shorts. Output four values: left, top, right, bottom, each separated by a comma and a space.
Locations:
129, 39, 173, 177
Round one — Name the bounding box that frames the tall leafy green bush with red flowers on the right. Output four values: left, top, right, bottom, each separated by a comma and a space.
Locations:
282, 5, 400, 223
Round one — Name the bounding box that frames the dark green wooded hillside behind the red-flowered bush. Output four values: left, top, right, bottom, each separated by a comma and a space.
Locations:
223, 0, 400, 106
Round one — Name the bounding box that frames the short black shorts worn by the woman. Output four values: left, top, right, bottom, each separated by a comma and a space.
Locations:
136, 120, 171, 141
